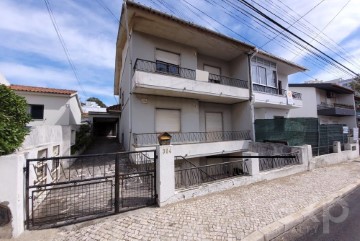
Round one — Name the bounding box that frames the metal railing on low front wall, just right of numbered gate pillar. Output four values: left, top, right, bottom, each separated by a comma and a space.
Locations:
175, 156, 249, 188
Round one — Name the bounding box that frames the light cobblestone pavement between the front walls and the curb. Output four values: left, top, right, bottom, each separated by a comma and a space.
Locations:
42, 162, 360, 241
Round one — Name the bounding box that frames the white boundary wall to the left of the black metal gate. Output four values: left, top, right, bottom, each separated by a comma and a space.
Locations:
0, 126, 71, 239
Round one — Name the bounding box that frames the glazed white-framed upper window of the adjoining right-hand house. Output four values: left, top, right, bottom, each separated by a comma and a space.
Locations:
251, 57, 277, 88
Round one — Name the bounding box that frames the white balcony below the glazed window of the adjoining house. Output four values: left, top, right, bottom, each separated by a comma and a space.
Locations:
253, 84, 302, 109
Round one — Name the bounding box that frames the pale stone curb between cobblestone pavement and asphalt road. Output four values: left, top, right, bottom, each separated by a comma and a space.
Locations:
242, 180, 360, 241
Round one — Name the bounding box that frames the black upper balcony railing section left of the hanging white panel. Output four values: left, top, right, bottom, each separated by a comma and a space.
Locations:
134, 59, 196, 80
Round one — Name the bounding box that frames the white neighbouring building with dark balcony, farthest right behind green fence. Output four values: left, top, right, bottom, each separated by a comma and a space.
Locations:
289, 82, 357, 128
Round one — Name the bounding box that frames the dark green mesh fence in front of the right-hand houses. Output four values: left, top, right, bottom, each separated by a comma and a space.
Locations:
255, 118, 347, 156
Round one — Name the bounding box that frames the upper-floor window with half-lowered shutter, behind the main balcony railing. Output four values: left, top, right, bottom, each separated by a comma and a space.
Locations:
155, 49, 180, 75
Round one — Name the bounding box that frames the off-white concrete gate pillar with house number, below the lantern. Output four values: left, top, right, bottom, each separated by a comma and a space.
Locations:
156, 145, 175, 207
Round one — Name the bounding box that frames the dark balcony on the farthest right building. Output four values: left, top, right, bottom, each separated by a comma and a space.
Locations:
317, 103, 356, 116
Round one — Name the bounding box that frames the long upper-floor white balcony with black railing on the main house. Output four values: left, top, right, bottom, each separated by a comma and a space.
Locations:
132, 59, 249, 104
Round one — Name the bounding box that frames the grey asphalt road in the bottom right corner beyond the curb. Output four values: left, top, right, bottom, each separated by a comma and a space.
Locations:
276, 188, 360, 241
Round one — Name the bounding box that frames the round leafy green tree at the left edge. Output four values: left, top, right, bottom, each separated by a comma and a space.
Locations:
0, 85, 31, 155
